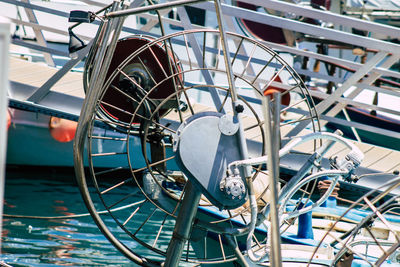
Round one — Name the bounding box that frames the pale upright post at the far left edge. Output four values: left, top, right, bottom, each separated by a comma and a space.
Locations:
0, 17, 10, 251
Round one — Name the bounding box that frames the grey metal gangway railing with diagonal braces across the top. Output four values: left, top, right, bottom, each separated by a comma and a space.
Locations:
0, 0, 400, 148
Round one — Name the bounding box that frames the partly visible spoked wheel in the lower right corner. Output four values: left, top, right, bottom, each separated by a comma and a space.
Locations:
310, 174, 400, 266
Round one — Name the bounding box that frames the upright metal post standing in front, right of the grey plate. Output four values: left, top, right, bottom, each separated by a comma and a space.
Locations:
263, 93, 282, 267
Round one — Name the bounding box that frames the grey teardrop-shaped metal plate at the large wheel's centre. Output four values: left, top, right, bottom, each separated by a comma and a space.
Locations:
177, 112, 245, 208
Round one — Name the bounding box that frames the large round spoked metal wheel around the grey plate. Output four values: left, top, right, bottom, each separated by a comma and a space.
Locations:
75, 30, 319, 265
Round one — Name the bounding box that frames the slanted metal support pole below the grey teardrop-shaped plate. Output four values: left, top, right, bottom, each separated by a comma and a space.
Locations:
164, 181, 201, 267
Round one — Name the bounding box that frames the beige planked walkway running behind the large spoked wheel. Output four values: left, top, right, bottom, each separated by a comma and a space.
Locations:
9, 57, 400, 173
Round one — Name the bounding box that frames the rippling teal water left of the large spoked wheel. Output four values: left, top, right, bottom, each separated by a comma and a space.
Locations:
1, 167, 136, 266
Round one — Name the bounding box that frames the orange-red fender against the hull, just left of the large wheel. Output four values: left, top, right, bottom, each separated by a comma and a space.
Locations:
49, 117, 78, 143
